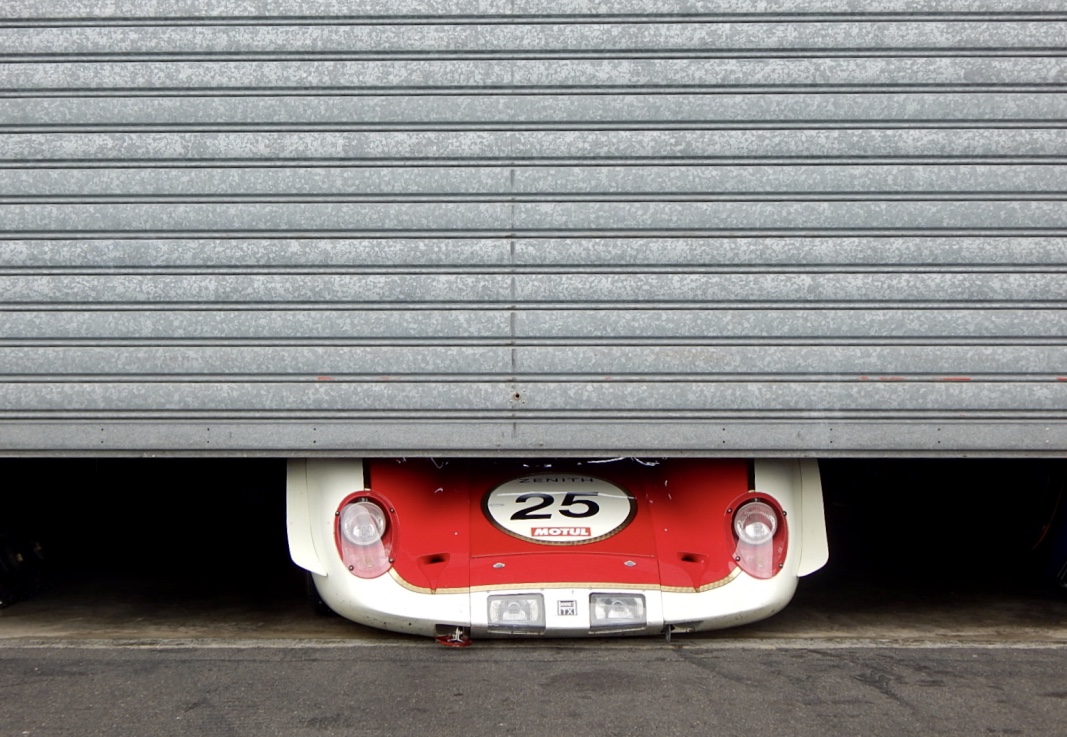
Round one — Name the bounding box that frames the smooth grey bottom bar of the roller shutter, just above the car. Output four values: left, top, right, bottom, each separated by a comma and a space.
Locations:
0, 416, 1067, 458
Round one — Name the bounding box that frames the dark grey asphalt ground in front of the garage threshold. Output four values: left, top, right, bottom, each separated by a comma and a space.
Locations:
0, 641, 1067, 737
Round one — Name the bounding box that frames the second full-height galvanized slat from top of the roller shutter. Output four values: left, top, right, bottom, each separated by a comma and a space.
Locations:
0, 55, 1067, 89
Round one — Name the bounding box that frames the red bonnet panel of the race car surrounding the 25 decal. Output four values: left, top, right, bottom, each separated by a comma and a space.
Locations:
364, 459, 786, 592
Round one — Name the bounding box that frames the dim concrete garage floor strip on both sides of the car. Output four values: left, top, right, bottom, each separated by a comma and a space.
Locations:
0, 572, 1067, 646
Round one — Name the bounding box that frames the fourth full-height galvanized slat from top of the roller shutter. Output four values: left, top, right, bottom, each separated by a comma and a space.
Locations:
6, 129, 1067, 154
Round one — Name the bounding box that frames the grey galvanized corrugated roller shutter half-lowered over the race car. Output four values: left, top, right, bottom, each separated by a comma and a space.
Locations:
0, 0, 1067, 454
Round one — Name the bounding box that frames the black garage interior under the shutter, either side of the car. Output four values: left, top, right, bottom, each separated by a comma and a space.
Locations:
0, 459, 1067, 631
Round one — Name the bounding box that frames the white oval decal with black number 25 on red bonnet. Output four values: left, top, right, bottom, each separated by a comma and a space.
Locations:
482, 474, 637, 545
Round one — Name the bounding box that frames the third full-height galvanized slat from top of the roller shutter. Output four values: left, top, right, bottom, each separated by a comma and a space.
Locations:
8, 91, 1067, 126
